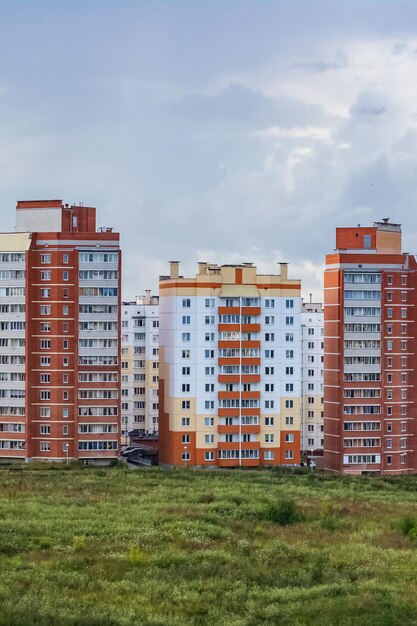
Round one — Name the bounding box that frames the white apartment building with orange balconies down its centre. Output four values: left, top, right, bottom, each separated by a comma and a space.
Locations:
159, 261, 301, 467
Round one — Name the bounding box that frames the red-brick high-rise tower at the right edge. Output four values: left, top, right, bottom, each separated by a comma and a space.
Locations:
324, 219, 417, 474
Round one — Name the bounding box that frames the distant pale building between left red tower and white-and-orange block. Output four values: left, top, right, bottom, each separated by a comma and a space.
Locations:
122, 290, 159, 443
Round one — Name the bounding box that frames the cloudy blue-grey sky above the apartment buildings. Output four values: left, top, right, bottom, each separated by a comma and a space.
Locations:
0, 0, 417, 300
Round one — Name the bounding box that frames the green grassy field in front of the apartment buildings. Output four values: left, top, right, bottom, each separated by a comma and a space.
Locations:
0, 468, 417, 626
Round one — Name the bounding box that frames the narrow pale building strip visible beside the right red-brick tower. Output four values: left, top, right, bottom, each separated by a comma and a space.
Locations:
300, 302, 324, 459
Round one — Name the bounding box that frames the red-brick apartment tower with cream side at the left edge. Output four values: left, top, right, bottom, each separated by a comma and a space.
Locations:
0, 200, 120, 462
